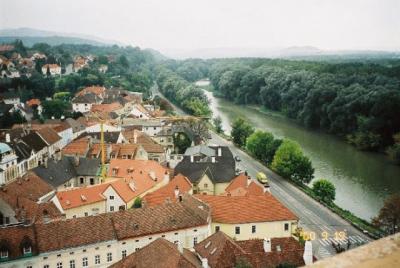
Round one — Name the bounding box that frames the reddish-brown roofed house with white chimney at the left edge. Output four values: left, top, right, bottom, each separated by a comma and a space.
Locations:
0, 172, 61, 226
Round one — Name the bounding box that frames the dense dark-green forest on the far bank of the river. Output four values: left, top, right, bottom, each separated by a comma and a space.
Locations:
163, 58, 400, 162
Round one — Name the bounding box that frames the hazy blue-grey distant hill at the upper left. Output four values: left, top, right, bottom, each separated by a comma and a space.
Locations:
0, 28, 124, 46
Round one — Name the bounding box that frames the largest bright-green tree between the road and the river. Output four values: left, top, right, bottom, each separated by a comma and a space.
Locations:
271, 140, 314, 183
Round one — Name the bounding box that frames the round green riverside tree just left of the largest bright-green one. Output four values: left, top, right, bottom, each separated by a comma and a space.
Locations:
246, 131, 282, 165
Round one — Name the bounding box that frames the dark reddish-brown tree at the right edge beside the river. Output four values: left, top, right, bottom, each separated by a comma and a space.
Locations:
372, 194, 400, 234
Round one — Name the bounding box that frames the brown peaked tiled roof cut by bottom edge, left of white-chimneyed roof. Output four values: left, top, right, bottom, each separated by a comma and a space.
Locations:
110, 238, 201, 268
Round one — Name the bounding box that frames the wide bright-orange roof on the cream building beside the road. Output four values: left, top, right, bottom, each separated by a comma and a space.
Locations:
196, 194, 298, 223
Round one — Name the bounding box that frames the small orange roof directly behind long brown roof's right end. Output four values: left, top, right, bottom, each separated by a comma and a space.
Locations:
143, 174, 192, 206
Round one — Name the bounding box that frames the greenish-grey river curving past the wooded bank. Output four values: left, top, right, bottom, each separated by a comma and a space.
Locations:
200, 82, 400, 220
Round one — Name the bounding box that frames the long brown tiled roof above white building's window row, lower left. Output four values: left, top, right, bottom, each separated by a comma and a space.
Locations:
29, 196, 209, 252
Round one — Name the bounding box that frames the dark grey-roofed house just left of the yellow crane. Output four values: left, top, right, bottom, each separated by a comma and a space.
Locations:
32, 156, 101, 191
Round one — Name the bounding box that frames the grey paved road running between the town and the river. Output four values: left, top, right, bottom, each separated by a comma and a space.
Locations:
153, 85, 372, 259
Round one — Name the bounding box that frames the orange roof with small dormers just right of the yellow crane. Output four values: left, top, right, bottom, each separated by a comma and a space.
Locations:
107, 159, 170, 196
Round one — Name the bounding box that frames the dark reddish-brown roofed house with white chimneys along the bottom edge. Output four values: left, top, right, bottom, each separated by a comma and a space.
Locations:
194, 231, 313, 268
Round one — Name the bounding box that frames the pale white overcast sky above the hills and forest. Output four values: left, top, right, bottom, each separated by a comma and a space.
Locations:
0, 0, 400, 50
